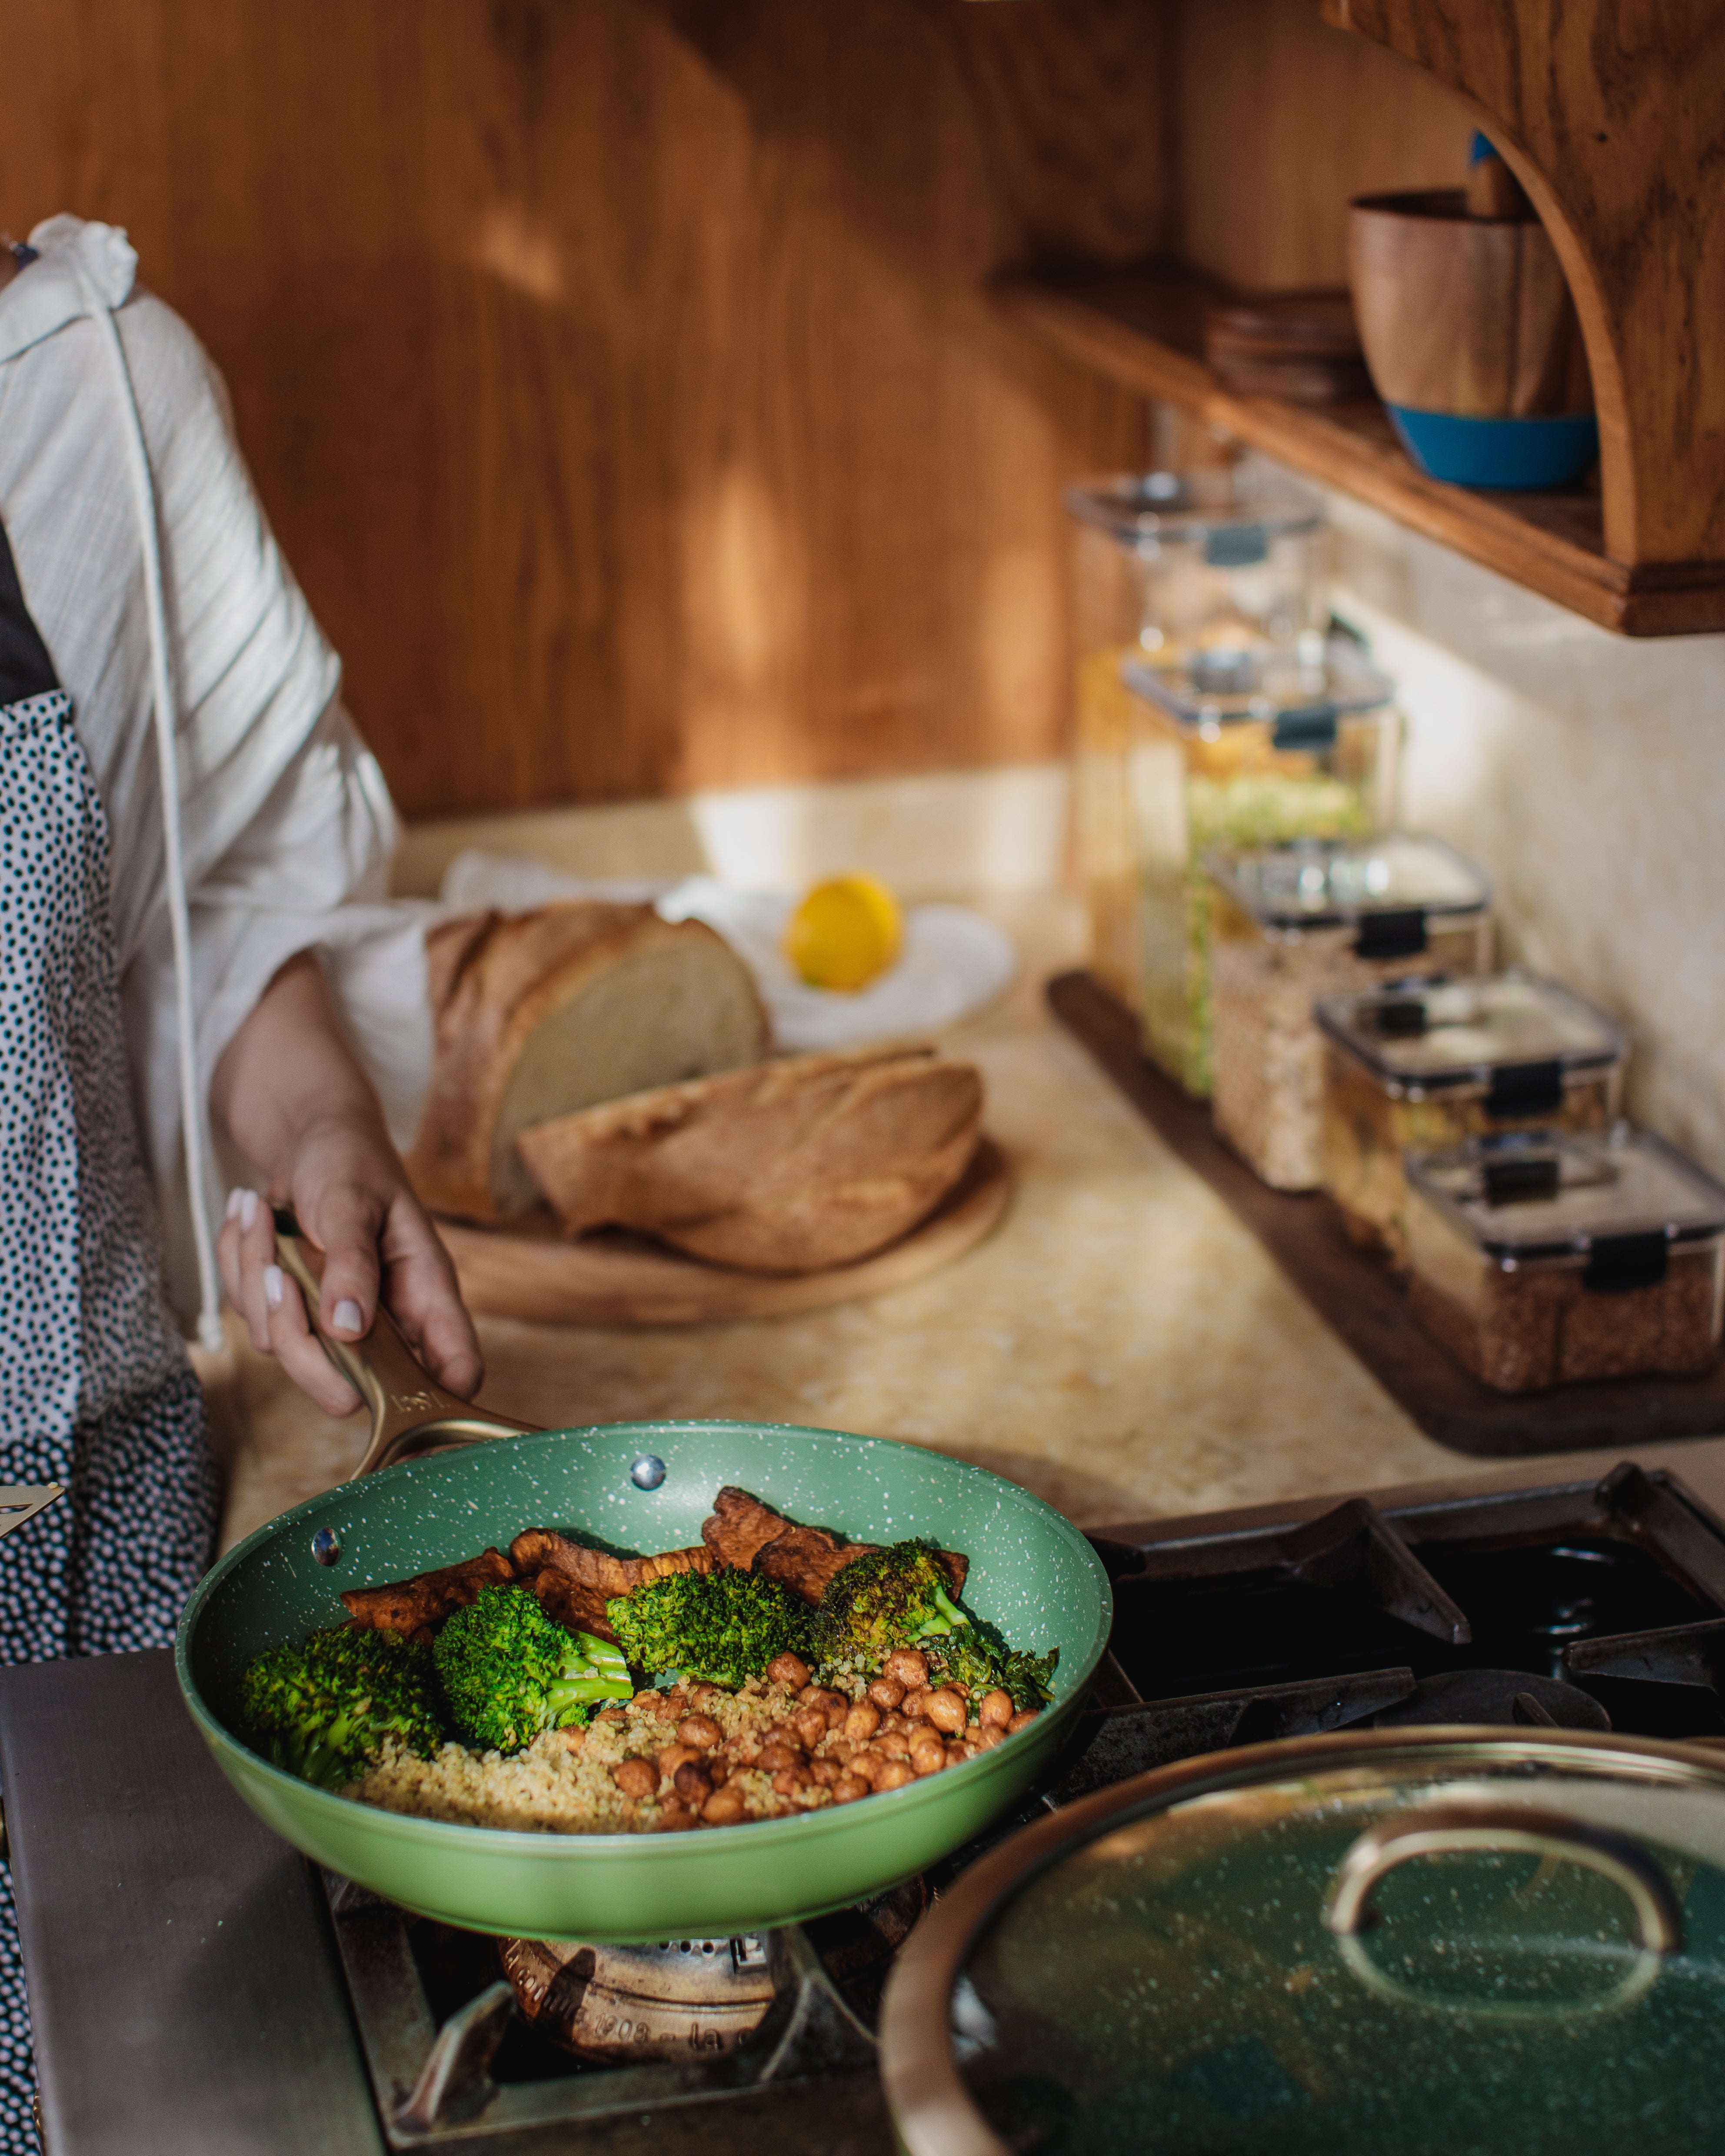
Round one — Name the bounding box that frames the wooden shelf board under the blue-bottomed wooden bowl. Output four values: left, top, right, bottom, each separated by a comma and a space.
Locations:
996, 261, 1725, 636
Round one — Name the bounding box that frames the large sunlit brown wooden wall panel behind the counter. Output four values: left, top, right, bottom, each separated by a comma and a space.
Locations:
0, 0, 1169, 815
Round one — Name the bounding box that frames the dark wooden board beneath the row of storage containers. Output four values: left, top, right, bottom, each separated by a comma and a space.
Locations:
1048, 972, 1725, 1460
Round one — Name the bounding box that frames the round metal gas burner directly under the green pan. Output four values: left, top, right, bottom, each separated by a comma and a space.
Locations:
498, 1934, 776, 2066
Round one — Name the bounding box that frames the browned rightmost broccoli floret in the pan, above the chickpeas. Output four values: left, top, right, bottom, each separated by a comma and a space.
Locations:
815, 1541, 1059, 1707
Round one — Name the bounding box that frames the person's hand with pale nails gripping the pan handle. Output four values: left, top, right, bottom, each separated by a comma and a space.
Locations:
211, 953, 483, 1414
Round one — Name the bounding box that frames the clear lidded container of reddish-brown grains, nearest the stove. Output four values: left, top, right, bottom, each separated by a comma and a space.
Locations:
1408, 1123, 1725, 1393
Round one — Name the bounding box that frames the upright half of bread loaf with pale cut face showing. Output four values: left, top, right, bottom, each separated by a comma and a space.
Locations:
407, 903, 772, 1220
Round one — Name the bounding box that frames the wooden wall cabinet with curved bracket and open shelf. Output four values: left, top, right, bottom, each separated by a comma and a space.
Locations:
1000, 0, 1725, 636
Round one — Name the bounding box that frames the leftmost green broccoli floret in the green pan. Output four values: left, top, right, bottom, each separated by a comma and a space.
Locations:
240, 1626, 444, 1790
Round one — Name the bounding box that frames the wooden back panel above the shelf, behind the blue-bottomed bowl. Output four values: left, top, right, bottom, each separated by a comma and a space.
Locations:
1173, 0, 1475, 291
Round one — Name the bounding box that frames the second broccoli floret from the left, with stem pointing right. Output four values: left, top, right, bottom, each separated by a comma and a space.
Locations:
431, 1587, 634, 1751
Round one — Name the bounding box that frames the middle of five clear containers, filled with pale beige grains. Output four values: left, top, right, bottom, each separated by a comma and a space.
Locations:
1210, 832, 1492, 1190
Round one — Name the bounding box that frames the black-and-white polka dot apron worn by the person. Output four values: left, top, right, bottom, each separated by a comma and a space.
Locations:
0, 513, 216, 2156
